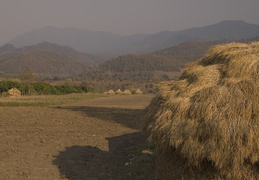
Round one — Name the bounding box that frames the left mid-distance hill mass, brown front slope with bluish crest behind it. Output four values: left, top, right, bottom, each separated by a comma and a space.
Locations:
0, 42, 106, 77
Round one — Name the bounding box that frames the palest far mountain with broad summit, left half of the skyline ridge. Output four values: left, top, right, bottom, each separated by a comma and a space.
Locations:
10, 26, 123, 52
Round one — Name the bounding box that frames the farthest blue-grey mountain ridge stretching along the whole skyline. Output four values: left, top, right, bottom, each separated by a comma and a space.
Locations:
10, 21, 259, 55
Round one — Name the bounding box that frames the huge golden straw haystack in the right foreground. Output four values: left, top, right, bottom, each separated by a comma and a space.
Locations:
144, 42, 259, 179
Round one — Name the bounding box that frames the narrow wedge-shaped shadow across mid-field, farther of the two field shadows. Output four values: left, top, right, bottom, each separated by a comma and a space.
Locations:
56, 106, 142, 130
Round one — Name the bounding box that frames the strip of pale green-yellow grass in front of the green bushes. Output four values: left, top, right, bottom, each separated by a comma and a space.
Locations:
0, 93, 105, 107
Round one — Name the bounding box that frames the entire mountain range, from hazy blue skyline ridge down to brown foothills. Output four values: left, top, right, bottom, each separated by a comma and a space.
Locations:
0, 21, 259, 81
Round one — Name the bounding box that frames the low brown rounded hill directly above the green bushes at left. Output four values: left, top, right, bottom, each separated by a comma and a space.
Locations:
0, 51, 87, 76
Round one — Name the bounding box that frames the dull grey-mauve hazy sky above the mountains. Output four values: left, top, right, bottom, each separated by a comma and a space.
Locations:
0, 0, 259, 45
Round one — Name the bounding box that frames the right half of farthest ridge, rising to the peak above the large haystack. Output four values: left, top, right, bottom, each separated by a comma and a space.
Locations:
135, 21, 259, 52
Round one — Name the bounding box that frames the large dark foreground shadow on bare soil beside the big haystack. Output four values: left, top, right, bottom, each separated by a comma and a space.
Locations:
53, 132, 146, 180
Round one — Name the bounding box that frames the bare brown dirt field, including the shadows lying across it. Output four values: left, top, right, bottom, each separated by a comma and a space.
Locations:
0, 95, 153, 180
